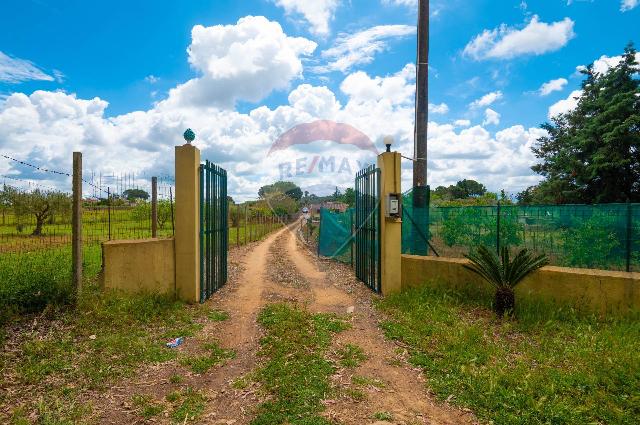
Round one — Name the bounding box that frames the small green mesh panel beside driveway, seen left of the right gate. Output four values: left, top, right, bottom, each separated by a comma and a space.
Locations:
318, 208, 354, 264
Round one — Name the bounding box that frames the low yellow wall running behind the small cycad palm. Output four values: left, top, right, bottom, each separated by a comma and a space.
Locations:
402, 255, 640, 313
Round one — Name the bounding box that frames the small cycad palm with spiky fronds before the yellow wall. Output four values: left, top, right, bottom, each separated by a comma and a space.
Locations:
464, 245, 549, 317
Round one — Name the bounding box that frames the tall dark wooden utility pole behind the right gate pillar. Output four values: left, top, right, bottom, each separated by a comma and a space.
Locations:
410, 0, 431, 255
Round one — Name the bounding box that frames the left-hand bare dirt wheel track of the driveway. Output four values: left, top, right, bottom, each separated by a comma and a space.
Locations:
89, 228, 287, 425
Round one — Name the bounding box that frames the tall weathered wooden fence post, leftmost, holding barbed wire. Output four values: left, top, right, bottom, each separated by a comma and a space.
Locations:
71, 152, 82, 294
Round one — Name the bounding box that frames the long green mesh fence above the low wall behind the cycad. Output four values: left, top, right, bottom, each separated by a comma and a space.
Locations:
402, 189, 640, 271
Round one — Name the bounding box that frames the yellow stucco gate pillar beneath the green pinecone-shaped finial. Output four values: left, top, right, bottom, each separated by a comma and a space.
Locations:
175, 144, 200, 303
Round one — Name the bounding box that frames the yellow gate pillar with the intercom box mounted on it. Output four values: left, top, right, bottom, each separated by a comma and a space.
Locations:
378, 152, 402, 295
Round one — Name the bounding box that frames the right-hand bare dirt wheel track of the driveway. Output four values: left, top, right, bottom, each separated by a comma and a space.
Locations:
280, 227, 475, 425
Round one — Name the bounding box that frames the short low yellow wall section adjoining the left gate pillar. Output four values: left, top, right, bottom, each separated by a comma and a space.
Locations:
102, 239, 176, 295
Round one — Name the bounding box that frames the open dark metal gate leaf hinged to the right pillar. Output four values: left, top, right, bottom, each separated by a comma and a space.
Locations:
355, 165, 381, 292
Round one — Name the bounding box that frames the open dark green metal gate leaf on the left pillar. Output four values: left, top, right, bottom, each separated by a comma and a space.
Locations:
200, 161, 229, 302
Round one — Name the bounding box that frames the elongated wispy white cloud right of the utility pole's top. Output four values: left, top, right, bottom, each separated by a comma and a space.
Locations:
464, 15, 575, 60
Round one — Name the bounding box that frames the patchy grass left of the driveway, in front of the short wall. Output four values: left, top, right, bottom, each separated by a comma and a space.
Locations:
0, 287, 206, 423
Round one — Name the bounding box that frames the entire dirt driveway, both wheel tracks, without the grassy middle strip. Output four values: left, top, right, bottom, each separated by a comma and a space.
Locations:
93, 226, 476, 425
